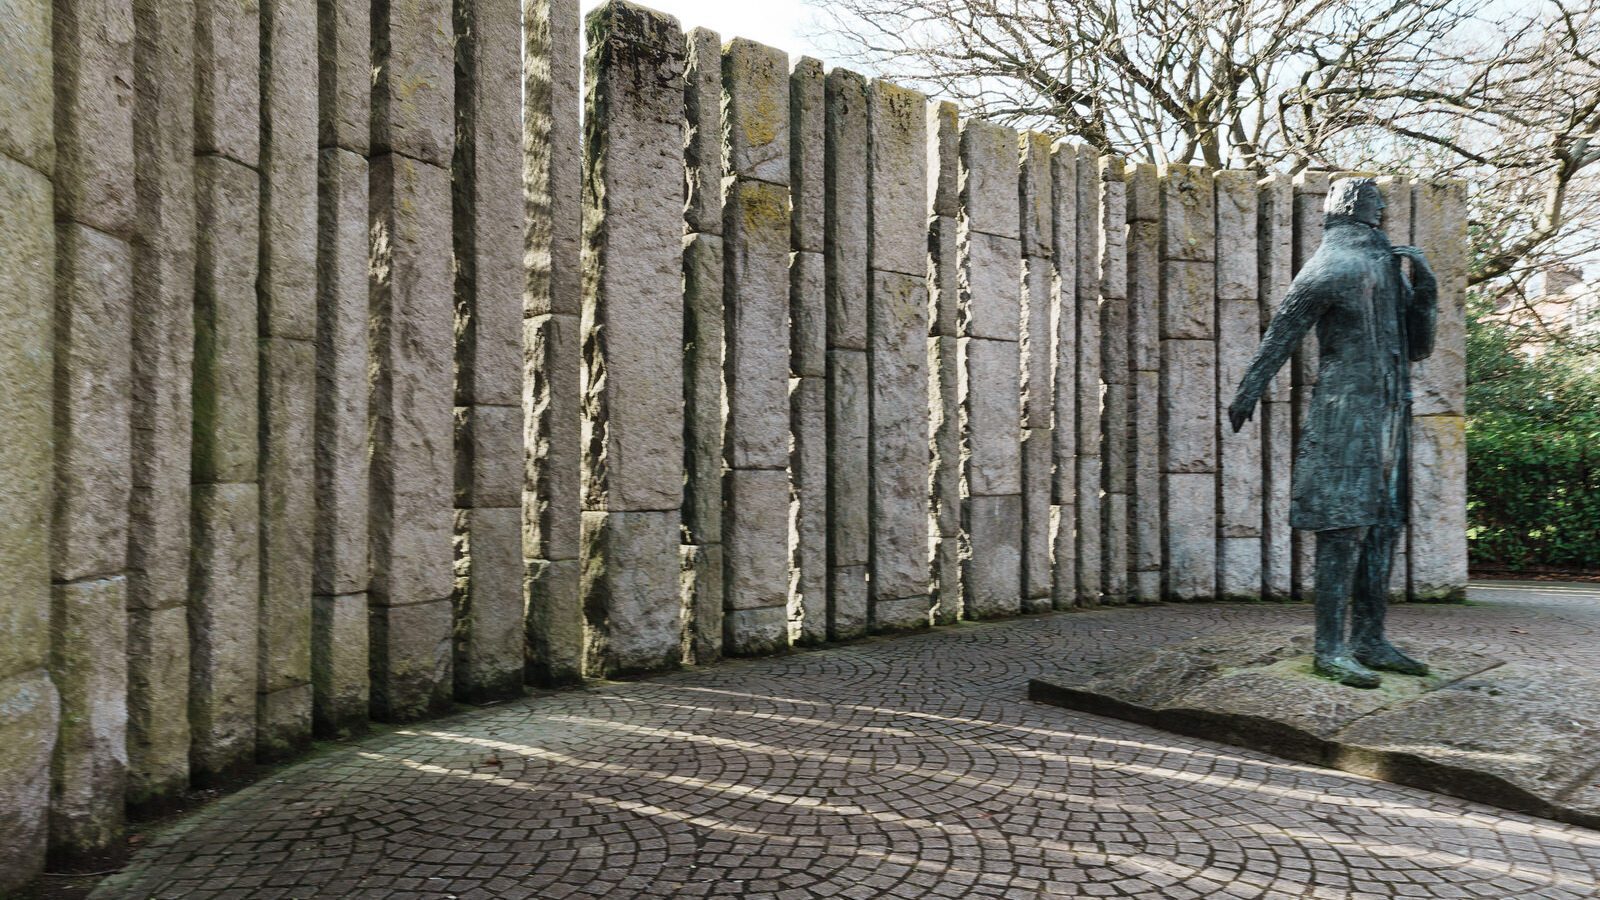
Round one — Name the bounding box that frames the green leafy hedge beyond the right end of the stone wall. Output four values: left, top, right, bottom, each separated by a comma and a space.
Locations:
1467, 415, 1600, 569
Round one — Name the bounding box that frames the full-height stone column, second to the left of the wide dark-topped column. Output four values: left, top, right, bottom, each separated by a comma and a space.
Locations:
451, 0, 526, 700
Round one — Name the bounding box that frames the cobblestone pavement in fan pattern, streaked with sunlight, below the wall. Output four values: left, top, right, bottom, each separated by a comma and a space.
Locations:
96, 585, 1600, 900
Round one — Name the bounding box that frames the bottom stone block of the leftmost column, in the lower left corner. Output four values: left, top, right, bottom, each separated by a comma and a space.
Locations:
0, 669, 61, 892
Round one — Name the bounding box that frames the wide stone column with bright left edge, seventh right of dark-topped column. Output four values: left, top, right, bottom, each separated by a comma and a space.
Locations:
957, 120, 1032, 618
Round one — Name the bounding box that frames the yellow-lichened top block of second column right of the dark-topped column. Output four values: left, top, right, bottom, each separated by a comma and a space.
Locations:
722, 37, 789, 186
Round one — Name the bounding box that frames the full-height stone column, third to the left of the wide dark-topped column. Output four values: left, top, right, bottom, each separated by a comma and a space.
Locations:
368, 0, 456, 721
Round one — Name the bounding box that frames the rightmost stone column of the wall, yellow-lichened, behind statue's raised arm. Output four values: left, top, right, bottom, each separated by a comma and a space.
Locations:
1408, 181, 1467, 601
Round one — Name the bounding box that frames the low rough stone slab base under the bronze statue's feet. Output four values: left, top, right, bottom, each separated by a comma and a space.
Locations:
1029, 631, 1600, 828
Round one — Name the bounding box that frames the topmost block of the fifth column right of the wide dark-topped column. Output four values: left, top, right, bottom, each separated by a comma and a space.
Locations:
867, 78, 928, 277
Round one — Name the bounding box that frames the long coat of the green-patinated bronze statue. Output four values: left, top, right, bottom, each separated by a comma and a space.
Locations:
1240, 216, 1438, 532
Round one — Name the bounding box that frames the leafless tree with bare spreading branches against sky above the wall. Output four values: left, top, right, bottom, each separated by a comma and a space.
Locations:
813, 0, 1600, 296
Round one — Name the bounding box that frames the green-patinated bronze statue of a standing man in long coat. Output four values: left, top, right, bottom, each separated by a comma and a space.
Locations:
1227, 178, 1438, 687
